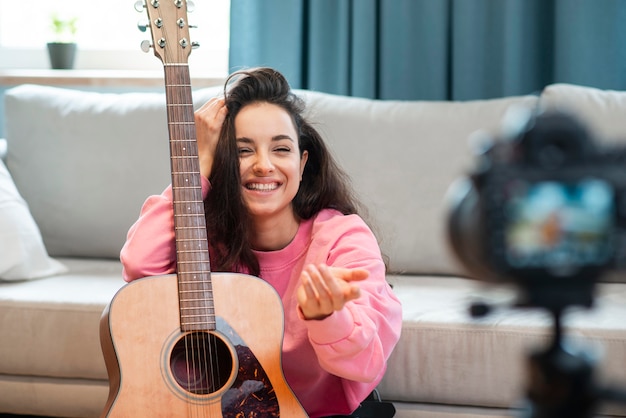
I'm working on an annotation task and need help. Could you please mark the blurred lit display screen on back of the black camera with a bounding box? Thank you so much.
[503,179,615,274]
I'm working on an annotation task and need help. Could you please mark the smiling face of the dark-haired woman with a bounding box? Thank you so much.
[235,102,308,222]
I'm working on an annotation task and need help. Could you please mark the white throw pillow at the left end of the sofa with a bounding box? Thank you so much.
[0,160,67,280]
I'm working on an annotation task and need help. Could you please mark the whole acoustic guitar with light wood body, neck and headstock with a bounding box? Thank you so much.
[100,0,307,418]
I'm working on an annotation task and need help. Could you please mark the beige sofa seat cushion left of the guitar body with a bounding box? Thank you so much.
[0,259,124,380]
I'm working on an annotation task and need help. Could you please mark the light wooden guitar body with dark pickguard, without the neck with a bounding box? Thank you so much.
[100,273,307,418]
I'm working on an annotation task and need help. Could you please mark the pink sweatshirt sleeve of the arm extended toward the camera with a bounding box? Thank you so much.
[303,215,402,386]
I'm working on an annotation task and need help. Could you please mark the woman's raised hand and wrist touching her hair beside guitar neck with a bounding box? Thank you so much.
[194,97,228,178]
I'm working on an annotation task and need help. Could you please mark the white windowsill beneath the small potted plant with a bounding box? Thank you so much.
[0,69,225,88]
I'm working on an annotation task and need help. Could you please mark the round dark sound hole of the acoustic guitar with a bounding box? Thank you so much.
[170,332,233,395]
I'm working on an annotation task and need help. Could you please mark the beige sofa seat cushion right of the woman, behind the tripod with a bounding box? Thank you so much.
[379,276,626,416]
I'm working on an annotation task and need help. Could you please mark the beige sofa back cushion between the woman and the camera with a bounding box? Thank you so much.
[303,92,537,274]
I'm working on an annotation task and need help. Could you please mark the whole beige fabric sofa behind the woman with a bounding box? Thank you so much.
[0,85,626,418]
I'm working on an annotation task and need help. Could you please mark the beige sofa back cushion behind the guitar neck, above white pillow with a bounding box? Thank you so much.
[5,85,221,258]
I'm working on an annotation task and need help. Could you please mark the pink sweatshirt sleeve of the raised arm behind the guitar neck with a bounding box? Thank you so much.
[120,177,210,282]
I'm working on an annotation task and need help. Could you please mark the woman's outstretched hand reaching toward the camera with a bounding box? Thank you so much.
[297,264,369,319]
